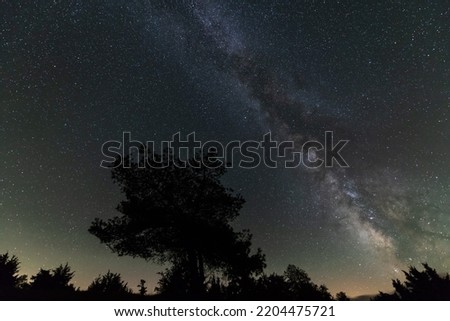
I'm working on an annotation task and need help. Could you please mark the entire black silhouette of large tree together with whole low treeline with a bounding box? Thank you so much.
[0,150,450,301]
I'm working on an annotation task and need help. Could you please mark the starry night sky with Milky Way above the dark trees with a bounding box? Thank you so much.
[0,0,450,296]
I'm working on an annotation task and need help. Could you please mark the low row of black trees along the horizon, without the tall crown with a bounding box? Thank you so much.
[0,253,450,301]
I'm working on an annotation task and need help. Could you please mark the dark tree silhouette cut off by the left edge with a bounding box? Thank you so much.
[0,253,27,297]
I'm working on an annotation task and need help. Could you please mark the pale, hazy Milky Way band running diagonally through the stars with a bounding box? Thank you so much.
[175,1,449,292]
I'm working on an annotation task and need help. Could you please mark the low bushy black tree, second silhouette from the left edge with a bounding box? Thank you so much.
[30,263,75,298]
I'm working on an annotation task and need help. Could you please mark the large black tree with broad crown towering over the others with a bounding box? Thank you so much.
[89,150,264,295]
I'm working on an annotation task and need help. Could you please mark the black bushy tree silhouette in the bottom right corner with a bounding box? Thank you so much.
[375,263,450,301]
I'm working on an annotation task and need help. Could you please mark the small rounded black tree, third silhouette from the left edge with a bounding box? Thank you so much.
[87,271,131,298]
